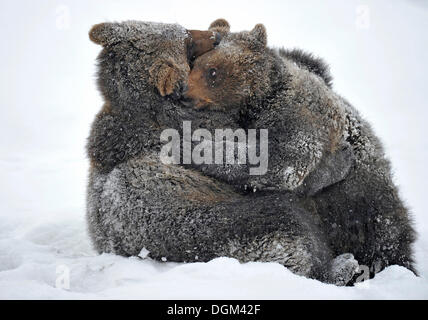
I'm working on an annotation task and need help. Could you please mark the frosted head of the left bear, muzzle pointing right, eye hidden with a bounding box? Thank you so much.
[89,21,220,102]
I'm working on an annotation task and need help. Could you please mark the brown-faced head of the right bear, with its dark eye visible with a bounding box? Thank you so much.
[184,19,271,110]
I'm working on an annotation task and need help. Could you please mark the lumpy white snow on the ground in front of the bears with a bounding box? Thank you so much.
[0,218,428,299]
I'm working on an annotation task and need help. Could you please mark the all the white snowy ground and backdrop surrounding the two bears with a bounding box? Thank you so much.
[0,0,428,299]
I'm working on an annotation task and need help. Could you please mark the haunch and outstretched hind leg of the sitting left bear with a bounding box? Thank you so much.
[88,154,342,283]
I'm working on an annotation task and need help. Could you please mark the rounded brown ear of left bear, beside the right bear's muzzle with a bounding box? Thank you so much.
[149,60,189,99]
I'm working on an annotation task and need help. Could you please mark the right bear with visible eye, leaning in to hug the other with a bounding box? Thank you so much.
[185,20,415,273]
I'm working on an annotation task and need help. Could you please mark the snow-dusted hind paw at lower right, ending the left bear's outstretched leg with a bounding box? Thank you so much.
[329,253,358,286]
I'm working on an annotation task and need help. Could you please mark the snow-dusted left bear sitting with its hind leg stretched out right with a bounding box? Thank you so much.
[87,21,353,284]
